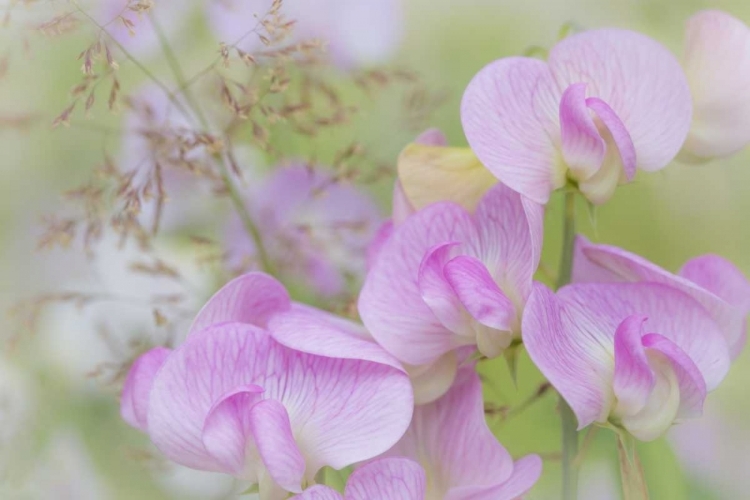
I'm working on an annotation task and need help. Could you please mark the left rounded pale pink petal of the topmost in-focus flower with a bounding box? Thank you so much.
[461,57,560,203]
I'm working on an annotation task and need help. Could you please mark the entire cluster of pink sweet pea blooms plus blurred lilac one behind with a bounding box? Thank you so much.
[114,6,750,500]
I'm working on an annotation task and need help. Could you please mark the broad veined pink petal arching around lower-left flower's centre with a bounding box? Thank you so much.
[148,323,413,477]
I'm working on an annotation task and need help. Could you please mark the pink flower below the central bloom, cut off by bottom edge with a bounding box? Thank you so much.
[386,366,542,500]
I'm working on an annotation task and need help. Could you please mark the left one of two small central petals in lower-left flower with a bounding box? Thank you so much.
[202,385,263,480]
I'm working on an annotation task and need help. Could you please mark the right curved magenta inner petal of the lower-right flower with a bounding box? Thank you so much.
[643,333,706,418]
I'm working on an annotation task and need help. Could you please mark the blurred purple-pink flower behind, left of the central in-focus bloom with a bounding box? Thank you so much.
[226,165,382,297]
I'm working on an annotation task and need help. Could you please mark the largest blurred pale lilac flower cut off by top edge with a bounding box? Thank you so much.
[208,0,403,68]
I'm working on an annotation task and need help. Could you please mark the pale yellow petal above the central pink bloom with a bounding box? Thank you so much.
[398,143,497,210]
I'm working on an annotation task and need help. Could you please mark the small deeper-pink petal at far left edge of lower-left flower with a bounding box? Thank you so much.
[120,347,172,432]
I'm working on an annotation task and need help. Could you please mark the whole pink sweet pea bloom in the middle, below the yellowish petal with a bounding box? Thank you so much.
[359,185,543,402]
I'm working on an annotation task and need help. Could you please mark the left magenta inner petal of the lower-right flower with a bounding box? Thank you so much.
[613,315,654,414]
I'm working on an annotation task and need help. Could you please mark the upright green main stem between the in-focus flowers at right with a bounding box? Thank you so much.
[557,190,578,500]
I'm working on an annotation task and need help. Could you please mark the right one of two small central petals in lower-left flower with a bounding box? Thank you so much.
[248,399,305,493]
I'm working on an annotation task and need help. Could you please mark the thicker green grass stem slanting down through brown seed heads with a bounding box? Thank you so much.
[150,11,274,274]
